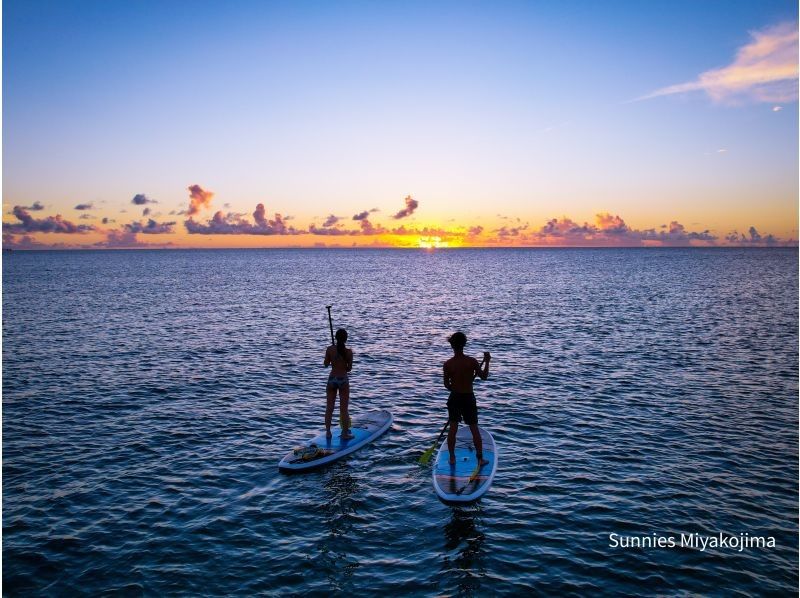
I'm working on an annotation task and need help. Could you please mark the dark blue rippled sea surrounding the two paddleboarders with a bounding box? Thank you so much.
[3,249,798,595]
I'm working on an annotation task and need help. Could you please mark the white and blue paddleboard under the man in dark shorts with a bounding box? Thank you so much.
[433,425,497,503]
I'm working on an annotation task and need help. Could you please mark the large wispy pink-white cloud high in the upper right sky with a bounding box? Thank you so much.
[635,22,798,103]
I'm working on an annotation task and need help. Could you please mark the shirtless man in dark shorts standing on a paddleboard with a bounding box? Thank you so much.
[444,332,492,465]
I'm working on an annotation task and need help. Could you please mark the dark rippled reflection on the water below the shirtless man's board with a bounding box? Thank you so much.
[441,504,486,595]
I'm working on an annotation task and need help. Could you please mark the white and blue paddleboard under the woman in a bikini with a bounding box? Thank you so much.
[278,410,392,472]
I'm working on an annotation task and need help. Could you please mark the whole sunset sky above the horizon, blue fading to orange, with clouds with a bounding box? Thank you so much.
[2,0,798,249]
